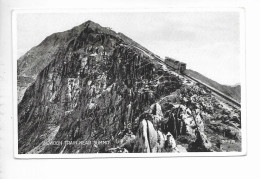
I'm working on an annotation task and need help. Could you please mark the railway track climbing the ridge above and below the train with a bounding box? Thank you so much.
[129,45,241,109]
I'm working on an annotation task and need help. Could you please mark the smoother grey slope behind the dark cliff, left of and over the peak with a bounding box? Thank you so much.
[17,21,152,103]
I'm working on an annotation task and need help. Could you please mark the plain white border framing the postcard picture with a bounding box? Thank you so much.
[12,8,247,159]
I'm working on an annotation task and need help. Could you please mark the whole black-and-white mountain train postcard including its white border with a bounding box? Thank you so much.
[12,8,246,158]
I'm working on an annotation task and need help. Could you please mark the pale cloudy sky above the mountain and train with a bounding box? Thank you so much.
[17,12,240,85]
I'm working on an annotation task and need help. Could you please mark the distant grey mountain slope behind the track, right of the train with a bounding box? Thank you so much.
[186,69,241,102]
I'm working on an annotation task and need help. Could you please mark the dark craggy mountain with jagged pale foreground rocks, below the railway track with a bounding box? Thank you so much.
[18,21,241,153]
